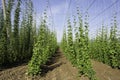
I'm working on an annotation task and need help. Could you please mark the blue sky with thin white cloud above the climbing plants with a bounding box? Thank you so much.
[0,0,120,42]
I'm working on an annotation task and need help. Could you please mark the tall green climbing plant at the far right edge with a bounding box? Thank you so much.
[109,16,120,68]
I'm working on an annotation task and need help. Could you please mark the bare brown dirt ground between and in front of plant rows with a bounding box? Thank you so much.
[0,50,120,80]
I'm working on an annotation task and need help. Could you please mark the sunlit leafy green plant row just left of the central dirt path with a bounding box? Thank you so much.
[28,15,57,75]
